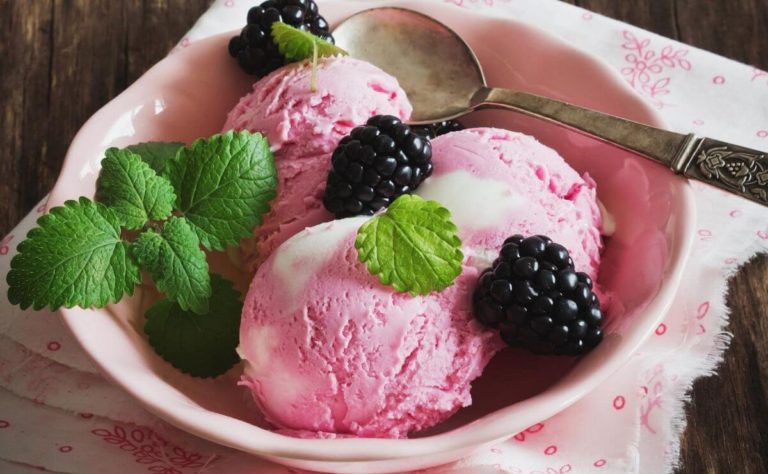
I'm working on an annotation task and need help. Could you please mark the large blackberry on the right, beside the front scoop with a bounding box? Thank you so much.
[473,235,603,355]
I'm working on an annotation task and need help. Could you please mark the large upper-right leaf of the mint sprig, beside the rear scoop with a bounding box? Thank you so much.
[167,132,277,250]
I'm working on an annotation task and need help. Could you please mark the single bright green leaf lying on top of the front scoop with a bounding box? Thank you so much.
[355,195,464,295]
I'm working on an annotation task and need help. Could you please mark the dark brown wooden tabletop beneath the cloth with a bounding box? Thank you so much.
[0,0,768,474]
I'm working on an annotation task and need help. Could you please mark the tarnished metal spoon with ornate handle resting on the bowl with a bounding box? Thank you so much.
[333,7,768,206]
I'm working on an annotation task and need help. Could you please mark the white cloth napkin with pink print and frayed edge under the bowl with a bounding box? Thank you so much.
[0,0,768,474]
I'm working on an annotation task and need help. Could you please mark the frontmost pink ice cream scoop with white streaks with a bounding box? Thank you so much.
[238,218,502,437]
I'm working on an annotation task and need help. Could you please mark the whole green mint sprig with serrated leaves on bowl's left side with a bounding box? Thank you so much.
[7,132,277,377]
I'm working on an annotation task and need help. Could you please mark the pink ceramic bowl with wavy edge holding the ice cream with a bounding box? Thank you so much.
[51,1,694,472]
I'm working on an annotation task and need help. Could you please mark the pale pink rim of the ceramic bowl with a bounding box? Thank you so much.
[49,0,696,462]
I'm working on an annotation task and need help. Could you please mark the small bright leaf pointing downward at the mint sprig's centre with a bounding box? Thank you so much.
[131,217,211,314]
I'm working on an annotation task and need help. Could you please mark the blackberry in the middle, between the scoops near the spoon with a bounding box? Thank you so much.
[323,115,432,218]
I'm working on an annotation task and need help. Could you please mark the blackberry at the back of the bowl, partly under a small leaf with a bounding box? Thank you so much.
[229,0,334,77]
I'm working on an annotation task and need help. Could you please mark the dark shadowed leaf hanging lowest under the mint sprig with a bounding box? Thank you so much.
[144,274,243,377]
